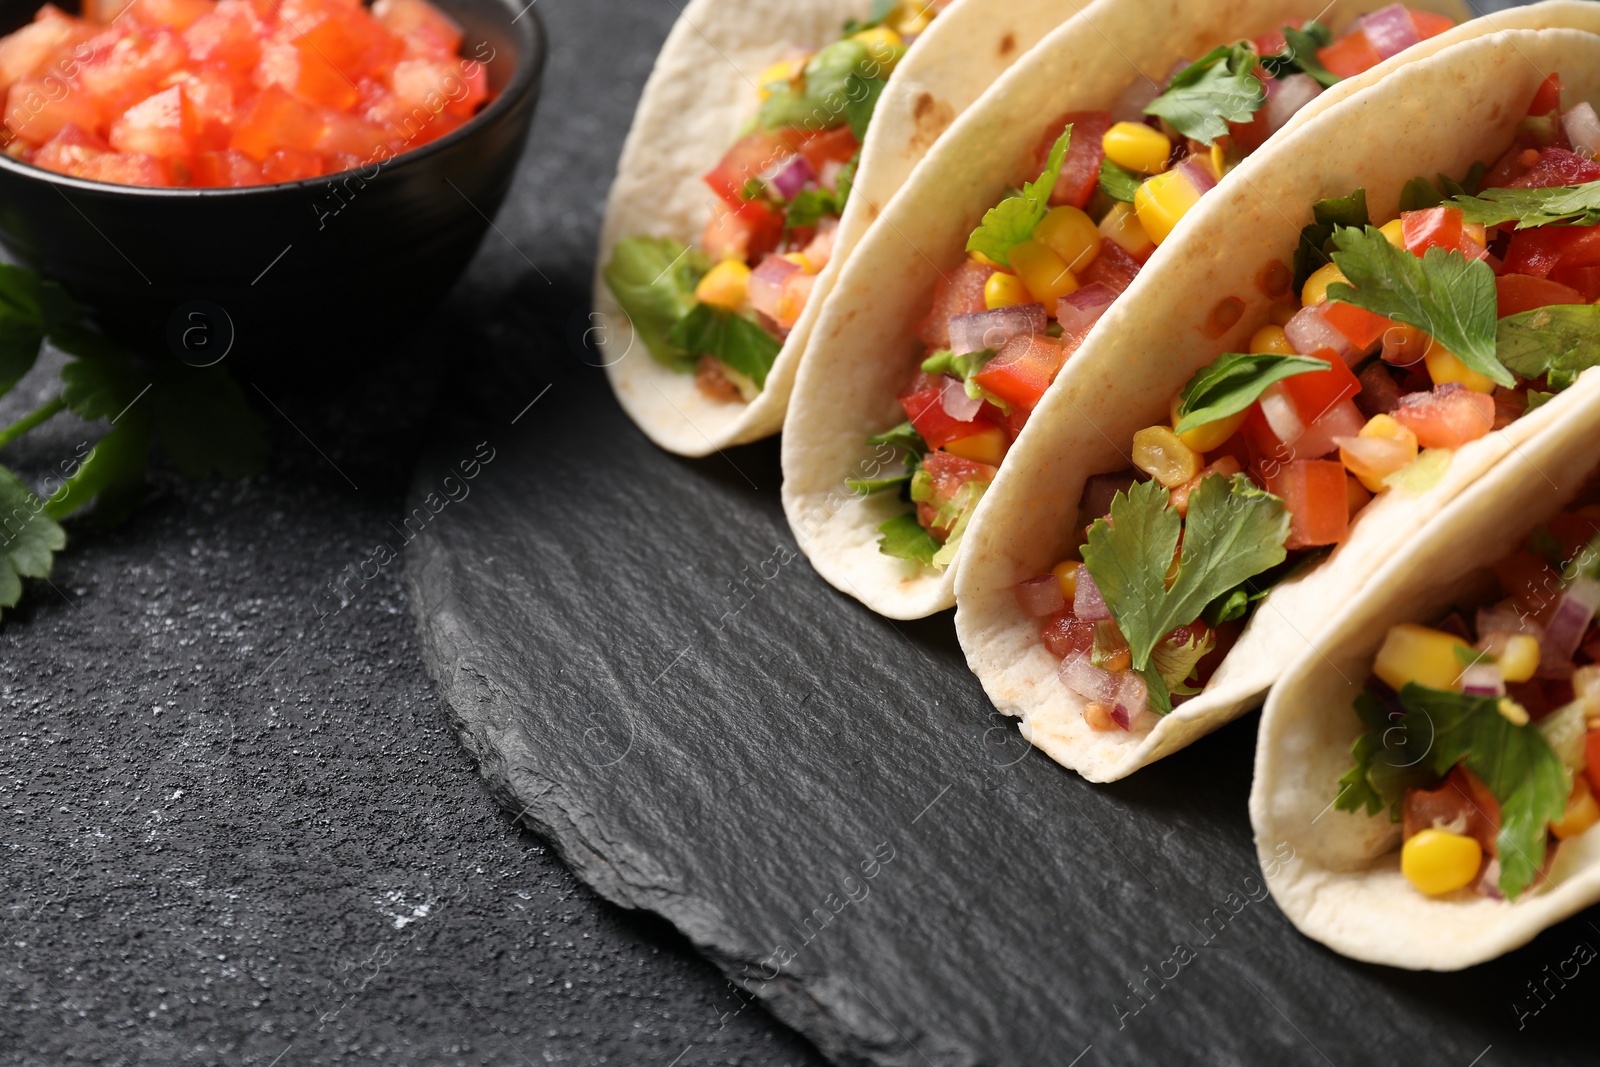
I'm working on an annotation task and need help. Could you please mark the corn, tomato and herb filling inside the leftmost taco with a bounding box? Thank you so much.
[603,0,950,402]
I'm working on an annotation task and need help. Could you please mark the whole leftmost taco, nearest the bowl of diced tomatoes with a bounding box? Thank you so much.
[589,0,1078,456]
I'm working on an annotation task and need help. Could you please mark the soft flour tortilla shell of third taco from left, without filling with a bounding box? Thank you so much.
[955,20,1600,781]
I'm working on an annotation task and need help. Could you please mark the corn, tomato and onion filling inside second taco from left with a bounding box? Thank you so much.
[850,5,1454,568]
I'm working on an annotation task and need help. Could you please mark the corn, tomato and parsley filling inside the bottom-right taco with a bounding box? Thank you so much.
[1334,504,1600,901]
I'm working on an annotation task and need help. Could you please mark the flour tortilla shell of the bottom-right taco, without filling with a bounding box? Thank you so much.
[1250,377,1600,971]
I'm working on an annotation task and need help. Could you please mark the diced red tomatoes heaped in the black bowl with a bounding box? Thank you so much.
[0,0,491,186]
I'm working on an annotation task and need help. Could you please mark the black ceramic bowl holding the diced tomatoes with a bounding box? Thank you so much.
[0,0,544,363]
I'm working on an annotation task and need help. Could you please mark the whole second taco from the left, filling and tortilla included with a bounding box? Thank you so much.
[784,0,1461,617]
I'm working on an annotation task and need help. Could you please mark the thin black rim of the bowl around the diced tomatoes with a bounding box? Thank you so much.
[0,0,549,200]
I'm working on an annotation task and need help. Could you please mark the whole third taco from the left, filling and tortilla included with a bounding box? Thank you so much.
[957,14,1600,781]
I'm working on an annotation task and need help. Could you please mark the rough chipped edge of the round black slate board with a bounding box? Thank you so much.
[405,556,921,1067]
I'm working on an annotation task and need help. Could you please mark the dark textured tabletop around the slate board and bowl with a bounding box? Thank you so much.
[0,0,821,1067]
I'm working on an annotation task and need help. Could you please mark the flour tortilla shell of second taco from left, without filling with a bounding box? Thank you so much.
[784,0,1472,619]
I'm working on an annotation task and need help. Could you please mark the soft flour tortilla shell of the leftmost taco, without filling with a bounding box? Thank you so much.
[592,0,1082,456]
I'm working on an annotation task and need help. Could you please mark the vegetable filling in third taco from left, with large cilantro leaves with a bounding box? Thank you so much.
[1016,75,1600,733]
